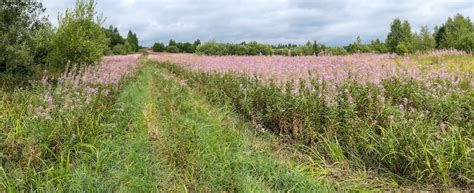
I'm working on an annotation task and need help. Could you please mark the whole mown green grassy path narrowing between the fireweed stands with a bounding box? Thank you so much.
[36,60,331,192]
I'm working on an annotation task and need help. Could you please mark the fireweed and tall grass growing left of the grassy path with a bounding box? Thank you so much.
[0,55,140,189]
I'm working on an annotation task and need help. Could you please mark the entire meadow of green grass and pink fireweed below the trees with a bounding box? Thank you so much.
[0,51,474,192]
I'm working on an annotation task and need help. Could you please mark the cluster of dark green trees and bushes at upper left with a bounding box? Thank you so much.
[0,0,140,74]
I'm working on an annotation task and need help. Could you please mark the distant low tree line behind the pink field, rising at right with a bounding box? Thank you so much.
[153,14,474,56]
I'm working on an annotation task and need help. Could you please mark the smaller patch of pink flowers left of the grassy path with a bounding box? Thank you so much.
[29,55,139,120]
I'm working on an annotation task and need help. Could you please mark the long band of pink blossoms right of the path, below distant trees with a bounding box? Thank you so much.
[149,50,473,92]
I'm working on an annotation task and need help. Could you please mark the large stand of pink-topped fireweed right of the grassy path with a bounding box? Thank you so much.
[153,50,474,188]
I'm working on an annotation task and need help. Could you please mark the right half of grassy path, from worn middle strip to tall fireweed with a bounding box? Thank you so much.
[144,61,328,192]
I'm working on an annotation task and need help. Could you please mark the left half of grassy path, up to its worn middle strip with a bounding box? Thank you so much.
[59,61,173,192]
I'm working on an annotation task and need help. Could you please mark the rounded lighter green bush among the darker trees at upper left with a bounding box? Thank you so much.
[47,0,109,69]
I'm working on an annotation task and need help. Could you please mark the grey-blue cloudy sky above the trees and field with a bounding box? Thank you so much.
[42,0,474,46]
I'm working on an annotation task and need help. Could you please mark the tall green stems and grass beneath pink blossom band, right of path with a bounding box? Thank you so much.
[161,53,474,188]
